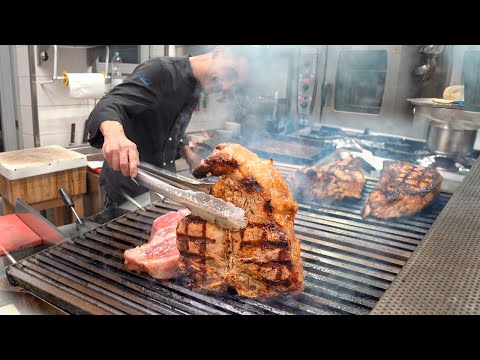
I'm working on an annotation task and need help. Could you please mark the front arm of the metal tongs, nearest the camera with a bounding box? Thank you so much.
[133,168,247,230]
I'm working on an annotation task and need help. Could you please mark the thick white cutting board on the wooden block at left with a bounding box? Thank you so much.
[0,145,87,180]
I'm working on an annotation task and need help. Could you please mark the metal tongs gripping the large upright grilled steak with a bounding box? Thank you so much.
[132,162,247,230]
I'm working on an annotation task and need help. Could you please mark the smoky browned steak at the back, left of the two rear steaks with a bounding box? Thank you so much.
[287,156,365,202]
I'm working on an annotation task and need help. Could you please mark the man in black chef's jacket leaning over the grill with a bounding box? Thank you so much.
[87,46,252,206]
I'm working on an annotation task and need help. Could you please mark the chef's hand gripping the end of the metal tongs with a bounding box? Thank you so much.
[100,120,139,177]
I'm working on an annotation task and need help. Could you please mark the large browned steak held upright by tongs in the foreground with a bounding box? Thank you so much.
[177,143,303,298]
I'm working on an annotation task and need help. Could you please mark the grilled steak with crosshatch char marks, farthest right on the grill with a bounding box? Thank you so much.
[362,161,443,219]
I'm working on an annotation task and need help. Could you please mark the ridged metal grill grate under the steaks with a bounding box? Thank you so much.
[6,164,451,315]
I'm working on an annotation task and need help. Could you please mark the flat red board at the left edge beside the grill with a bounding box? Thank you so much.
[0,214,43,256]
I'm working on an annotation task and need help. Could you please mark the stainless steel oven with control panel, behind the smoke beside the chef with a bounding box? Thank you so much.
[240,45,423,137]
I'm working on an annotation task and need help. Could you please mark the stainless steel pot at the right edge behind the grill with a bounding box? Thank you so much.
[427,121,477,155]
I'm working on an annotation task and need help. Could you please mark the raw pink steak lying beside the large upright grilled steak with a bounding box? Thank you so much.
[123,209,190,279]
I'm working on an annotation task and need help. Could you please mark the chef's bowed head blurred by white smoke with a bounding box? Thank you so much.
[199,45,253,94]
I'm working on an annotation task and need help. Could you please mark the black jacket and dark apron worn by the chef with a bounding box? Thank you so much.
[87,56,201,204]
